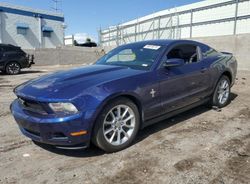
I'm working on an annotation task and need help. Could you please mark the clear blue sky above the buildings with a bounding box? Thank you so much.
[0,0,200,41]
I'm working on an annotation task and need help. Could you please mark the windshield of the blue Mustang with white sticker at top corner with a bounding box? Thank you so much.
[96,44,163,70]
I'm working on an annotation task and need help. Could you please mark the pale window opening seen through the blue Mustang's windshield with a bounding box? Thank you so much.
[107,49,136,63]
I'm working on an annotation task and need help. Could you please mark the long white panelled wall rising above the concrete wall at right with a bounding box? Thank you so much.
[99,0,250,47]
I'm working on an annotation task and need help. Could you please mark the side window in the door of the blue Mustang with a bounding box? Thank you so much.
[167,44,201,64]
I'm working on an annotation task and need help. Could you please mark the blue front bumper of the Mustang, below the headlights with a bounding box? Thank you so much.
[11,100,90,147]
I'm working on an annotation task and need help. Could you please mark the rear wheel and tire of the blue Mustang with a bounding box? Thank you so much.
[211,75,231,108]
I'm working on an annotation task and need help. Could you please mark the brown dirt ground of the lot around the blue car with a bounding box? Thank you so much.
[0,67,250,184]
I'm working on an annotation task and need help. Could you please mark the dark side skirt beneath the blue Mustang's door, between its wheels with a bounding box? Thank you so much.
[141,98,209,129]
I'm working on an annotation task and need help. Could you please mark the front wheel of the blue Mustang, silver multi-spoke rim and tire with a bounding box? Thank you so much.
[92,98,140,153]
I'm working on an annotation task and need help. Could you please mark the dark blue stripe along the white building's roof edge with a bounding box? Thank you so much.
[0,6,64,22]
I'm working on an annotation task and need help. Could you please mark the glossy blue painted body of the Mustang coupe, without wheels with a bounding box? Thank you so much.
[11,40,237,149]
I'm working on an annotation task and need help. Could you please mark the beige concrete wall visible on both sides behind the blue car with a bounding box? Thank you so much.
[26,34,250,70]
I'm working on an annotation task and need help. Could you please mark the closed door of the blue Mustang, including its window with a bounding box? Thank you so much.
[158,43,209,113]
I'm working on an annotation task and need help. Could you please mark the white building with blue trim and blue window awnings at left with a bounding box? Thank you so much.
[0,3,64,49]
